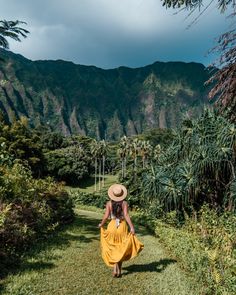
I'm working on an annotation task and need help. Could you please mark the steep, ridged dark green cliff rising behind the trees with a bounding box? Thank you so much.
[0,50,209,139]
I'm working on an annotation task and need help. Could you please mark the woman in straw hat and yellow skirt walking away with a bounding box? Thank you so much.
[98,184,144,277]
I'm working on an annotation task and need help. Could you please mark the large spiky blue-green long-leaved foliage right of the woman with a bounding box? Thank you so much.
[143,109,236,211]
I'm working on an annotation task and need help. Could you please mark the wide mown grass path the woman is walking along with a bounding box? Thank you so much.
[0,210,198,295]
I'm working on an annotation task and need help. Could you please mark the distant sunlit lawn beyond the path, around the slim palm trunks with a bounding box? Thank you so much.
[66,175,118,193]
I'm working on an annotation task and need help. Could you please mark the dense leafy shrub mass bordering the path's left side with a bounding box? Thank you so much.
[0,163,74,271]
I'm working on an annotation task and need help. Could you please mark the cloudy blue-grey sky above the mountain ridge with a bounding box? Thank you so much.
[0,0,232,68]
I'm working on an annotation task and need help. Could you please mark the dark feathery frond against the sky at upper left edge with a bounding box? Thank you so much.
[0,20,29,49]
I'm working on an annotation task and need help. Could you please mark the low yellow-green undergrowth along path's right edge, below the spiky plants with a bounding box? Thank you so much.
[132,206,236,295]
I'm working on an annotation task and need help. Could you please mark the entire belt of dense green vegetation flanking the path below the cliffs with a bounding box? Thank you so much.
[0,109,236,294]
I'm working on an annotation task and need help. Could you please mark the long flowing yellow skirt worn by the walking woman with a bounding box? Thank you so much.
[101,219,144,267]
